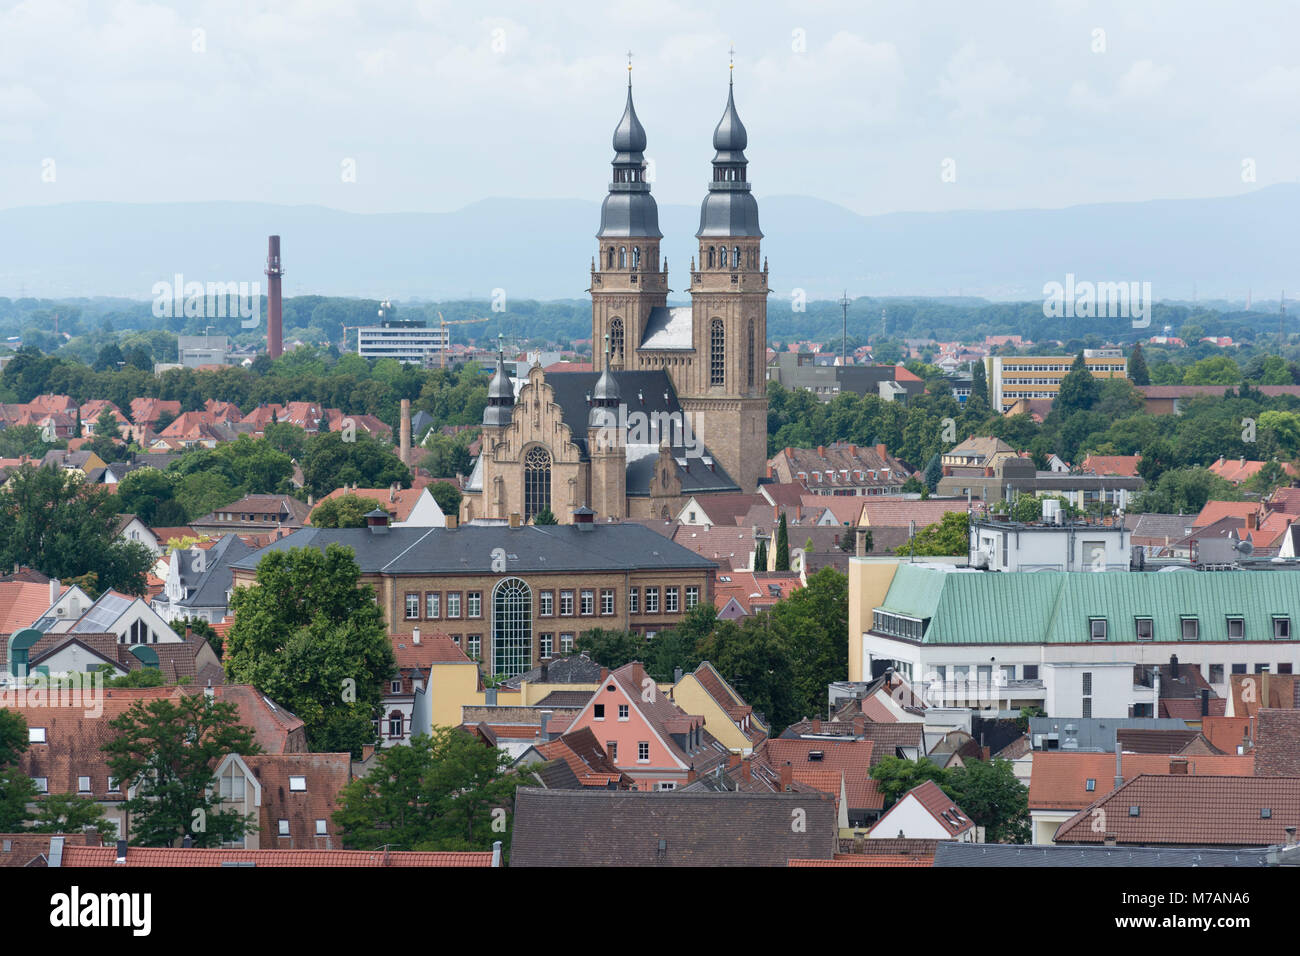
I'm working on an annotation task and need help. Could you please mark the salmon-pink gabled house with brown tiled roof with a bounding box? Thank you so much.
[568,661,728,791]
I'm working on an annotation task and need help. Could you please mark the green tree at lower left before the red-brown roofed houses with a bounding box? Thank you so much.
[103,693,261,847]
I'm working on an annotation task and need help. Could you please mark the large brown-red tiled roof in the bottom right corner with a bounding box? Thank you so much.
[1056,774,1300,847]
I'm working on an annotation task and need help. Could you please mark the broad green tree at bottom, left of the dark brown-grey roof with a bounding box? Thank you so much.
[334,727,529,851]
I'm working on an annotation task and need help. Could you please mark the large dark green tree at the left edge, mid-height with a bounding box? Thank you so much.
[0,464,153,594]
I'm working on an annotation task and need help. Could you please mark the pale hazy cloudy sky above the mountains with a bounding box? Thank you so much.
[0,0,1300,213]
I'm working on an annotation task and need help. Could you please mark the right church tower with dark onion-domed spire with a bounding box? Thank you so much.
[679,71,768,492]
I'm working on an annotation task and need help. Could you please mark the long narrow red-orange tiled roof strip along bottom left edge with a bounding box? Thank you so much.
[64,847,491,866]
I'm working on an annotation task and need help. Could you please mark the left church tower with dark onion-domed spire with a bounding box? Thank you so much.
[590,65,668,372]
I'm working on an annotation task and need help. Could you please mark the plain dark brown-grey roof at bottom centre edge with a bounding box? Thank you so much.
[510,787,837,866]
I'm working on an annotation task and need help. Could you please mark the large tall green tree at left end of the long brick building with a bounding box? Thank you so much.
[225,544,395,754]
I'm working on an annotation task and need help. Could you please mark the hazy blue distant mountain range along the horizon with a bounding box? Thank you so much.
[0,183,1300,302]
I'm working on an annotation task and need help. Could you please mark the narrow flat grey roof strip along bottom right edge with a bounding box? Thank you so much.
[935,843,1269,868]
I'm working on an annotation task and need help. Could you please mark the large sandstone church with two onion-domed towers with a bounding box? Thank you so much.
[460,68,768,523]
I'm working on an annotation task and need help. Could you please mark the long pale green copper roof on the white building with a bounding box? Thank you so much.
[881,564,1300,644]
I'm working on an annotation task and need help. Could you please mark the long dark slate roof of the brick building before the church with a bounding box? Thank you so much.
[231,524,716,574]
